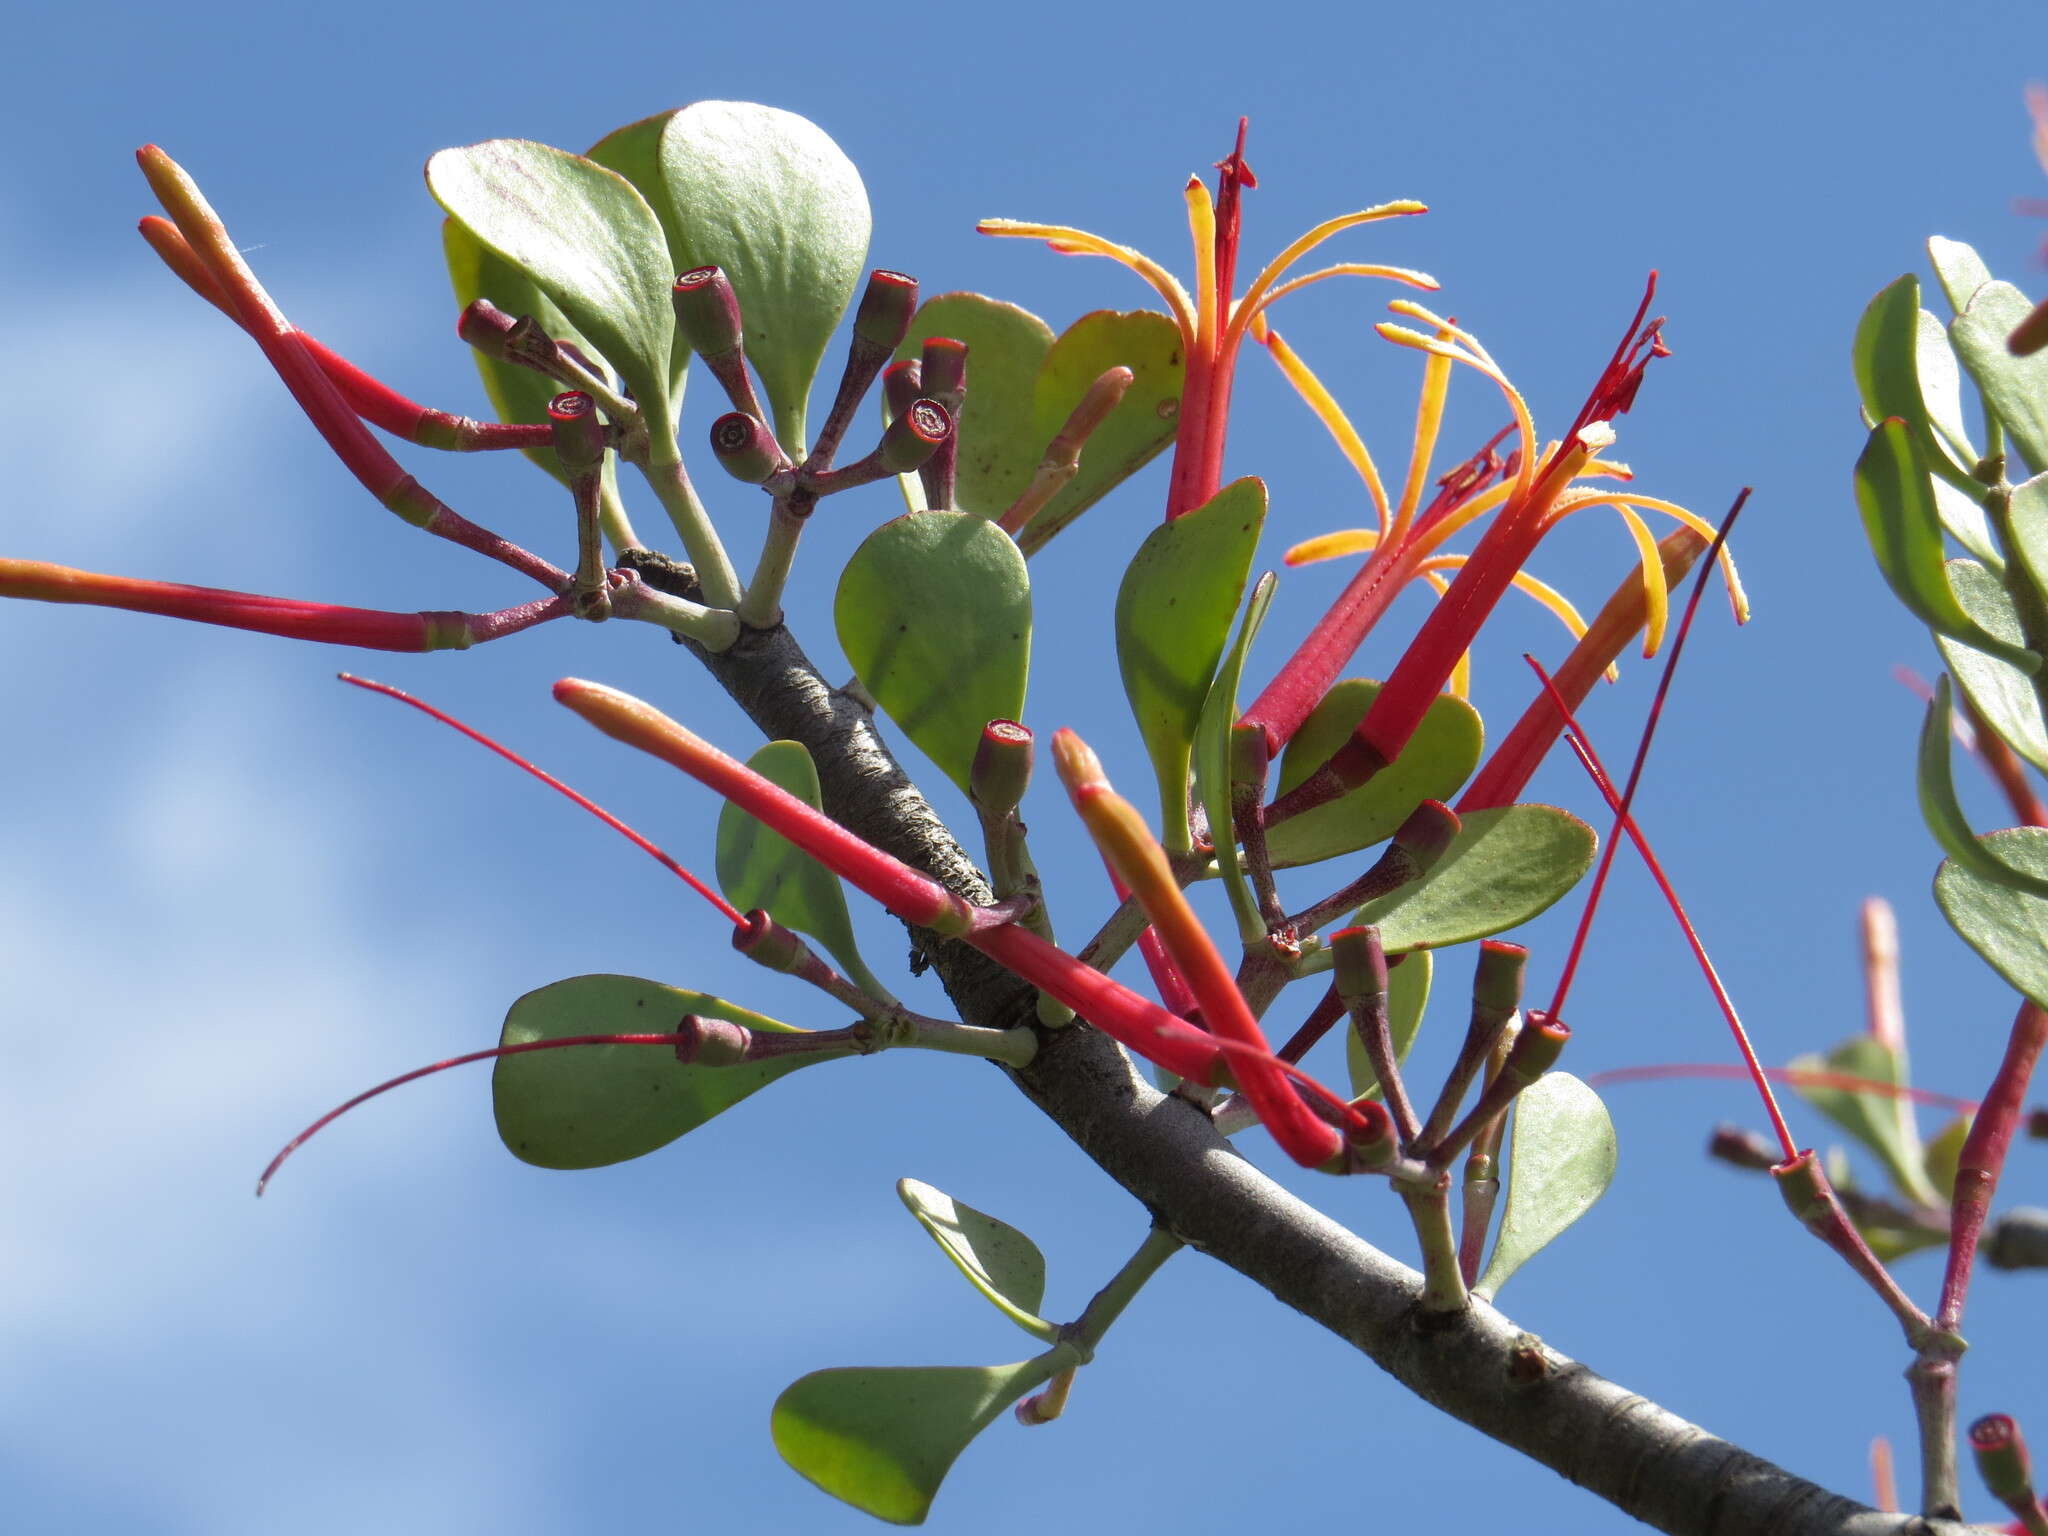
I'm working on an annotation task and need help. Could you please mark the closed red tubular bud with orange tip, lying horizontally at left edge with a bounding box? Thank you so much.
[0,559,567,651]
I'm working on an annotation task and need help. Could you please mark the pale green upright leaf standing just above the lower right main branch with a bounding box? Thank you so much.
[1473,1071,1614,1298]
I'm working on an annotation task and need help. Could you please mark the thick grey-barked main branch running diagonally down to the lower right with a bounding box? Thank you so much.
[643,567,1968,1536]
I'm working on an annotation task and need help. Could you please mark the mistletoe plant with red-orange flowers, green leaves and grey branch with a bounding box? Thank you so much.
[0,102,2048,1532]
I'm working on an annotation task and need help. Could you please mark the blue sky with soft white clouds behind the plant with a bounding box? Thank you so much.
[0,0,2048,1536]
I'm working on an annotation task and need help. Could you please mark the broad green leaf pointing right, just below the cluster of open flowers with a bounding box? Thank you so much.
[1352,805,1599,954]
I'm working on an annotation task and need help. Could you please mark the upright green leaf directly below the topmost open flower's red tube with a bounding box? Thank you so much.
[1116,475,1266,854]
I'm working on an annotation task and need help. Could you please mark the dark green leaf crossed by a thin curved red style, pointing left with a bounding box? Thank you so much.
[492,977,846,1167]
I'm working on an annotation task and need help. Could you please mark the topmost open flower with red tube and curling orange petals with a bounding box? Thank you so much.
[975,119,1436,522]
